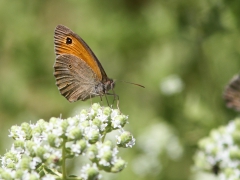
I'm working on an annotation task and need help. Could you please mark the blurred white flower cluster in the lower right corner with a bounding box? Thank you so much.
[194,118,240,180]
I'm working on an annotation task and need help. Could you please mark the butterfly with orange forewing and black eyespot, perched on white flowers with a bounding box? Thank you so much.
[54,25,115,102]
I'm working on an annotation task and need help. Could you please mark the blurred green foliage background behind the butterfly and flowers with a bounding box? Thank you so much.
[0,0,240,180]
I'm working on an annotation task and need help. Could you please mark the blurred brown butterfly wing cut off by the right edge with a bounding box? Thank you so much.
[223,75,240,111]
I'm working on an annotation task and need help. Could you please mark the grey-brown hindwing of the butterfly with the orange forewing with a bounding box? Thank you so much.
[54,54,100,102]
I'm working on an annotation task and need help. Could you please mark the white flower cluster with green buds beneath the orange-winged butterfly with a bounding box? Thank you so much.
[0,104,135,180]
